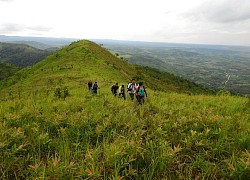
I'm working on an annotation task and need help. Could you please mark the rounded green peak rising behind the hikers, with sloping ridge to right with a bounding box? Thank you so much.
[2,40,213,94]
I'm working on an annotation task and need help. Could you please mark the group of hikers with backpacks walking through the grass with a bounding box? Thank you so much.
[88,79,147,105]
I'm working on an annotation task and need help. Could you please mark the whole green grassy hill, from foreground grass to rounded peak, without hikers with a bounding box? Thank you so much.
[0,41,250,179]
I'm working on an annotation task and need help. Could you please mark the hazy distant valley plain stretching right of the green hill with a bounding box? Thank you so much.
[94,40,250,95]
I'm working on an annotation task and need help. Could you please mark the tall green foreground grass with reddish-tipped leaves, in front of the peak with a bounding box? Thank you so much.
[0,84,250,179]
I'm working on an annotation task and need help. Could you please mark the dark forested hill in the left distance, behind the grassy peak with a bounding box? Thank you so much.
[0,42,52,67]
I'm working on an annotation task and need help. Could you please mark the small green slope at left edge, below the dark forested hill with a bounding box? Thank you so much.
[0,62,21,81]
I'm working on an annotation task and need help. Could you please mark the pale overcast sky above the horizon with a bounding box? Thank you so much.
[0,0,250,45]
